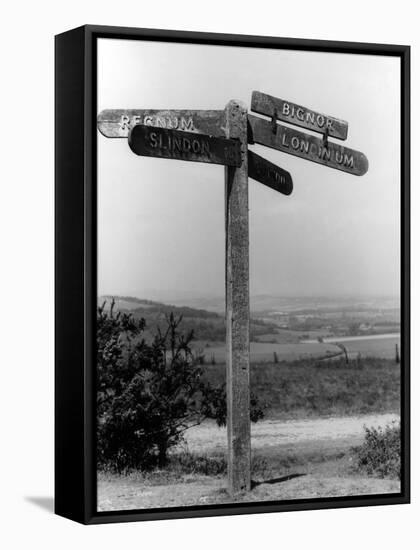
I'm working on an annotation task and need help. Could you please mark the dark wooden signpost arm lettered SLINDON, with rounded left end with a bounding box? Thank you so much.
[128,124,241,166]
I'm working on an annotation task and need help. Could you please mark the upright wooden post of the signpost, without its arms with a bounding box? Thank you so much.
[225,101,251,494]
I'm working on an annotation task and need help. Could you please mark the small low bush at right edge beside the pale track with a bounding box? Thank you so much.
[355,422,401,479]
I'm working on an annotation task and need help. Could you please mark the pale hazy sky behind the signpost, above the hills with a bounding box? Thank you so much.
[98,39,400,300]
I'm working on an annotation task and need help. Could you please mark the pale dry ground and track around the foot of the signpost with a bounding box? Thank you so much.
[98,414,400,511]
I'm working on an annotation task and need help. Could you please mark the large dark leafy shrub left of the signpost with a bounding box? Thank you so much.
[97,302,264,472]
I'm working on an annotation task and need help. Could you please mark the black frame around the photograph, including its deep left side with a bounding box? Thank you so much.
[55,25,410,524]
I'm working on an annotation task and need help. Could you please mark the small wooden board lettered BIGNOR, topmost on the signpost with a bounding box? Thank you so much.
[251,92,349,139]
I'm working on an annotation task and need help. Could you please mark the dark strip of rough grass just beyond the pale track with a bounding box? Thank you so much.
[204,358,400,419]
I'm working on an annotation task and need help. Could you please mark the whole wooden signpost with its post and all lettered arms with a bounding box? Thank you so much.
[98,92,368,495]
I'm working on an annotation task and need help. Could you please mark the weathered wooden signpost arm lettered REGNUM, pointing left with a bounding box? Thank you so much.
[97,109,225,138]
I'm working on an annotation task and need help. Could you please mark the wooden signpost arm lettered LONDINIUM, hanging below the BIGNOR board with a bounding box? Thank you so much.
[248,115,369,176]
